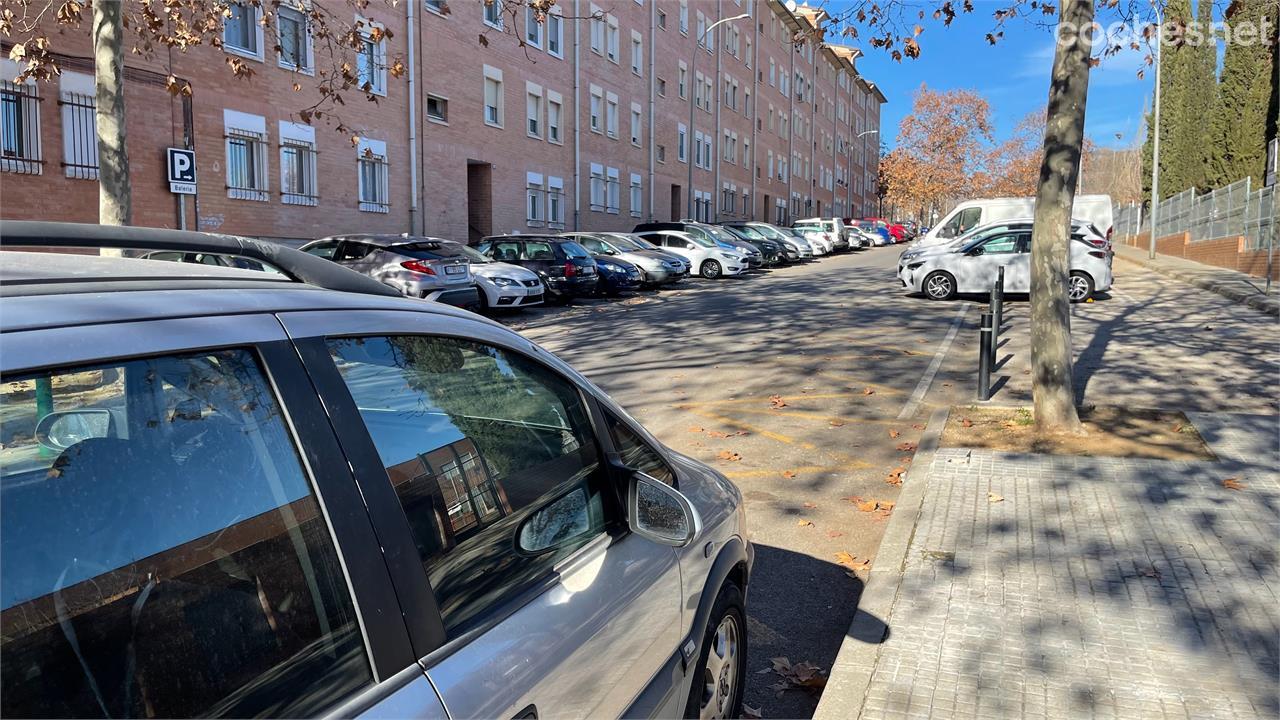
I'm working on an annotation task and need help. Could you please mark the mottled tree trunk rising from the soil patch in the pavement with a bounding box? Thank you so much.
[1030,0,1093,432]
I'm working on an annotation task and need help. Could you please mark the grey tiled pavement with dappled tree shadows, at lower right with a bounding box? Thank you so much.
[861,414,1280,719]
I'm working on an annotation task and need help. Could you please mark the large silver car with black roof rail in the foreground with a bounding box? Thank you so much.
[0,220,754,719]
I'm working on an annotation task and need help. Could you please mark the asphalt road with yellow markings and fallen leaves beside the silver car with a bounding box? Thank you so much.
[502,247,975,717]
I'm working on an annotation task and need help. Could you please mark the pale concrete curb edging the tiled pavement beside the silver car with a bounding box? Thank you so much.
[813,407,950,720]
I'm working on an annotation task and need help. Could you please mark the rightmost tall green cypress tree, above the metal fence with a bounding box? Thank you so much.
[1211,0,1280,187]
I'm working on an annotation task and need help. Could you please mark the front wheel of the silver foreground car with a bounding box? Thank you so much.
[685,582,746,720]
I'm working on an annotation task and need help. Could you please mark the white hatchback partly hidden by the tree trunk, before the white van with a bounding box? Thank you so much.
[897,227,1111,302]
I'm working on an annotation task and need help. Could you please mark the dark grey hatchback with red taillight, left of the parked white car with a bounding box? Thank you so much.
[301,234,480,307]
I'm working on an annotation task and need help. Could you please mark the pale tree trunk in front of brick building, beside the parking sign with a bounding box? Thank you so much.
[93,0,133,225]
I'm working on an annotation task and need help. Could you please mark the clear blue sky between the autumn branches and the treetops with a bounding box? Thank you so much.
[827,0,1152,147]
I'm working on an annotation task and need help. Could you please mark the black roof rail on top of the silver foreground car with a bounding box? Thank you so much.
[0,220,401,297]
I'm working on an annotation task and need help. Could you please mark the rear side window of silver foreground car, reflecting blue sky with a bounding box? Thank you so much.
[0,350,372,717]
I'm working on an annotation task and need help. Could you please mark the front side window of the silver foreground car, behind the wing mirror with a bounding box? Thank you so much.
[329,336,621,637]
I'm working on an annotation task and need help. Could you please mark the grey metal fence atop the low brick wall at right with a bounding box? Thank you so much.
[1115,178,1280,250]
